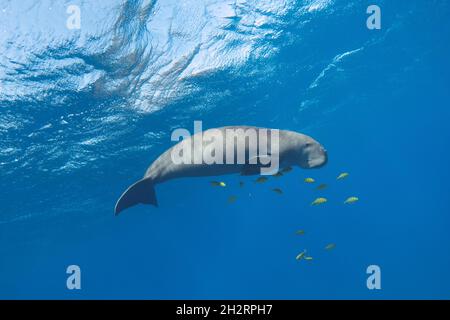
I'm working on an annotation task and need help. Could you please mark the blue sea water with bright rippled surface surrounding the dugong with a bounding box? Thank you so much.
[0,0,450,299]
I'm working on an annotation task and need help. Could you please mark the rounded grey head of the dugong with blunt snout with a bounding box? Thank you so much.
[296,134,328,169]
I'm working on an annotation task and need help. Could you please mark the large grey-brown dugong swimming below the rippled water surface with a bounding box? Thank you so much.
[114,126,328,215]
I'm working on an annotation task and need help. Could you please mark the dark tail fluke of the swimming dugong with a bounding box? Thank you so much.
[114,178,158,215]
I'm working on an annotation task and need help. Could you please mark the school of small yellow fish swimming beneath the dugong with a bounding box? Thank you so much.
[211,167,359,261]
